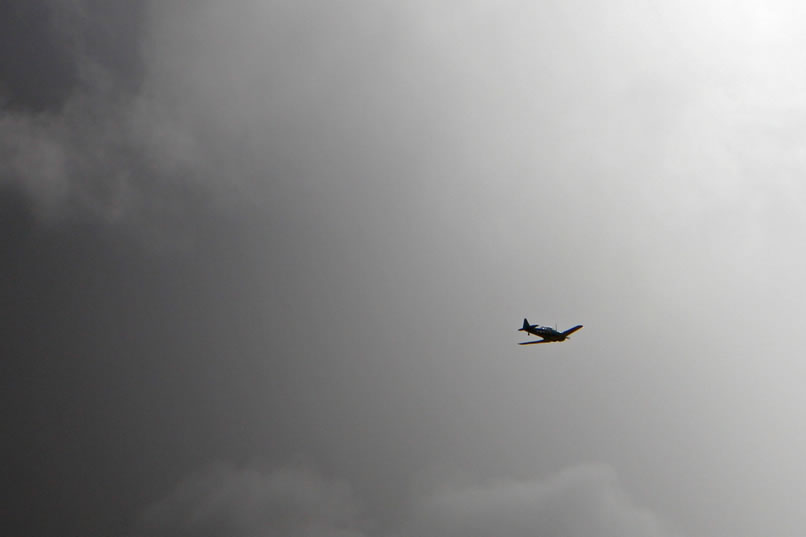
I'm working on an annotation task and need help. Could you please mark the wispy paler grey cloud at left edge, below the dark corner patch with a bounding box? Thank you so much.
[0,77,203,231]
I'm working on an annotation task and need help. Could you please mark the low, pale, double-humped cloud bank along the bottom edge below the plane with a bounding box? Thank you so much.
[137,465,674,537]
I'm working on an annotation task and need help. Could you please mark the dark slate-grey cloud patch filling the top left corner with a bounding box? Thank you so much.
[0,0,145,111]
